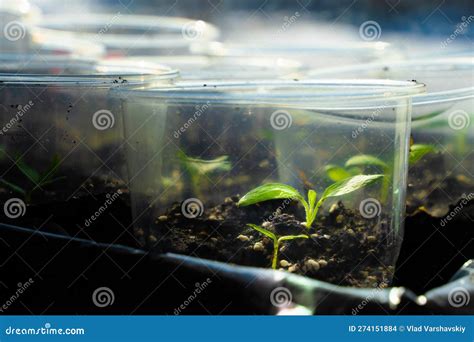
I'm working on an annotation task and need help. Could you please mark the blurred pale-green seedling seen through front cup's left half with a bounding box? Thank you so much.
[178,151,232,194]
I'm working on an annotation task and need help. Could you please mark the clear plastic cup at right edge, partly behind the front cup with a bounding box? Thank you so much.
[310,57,474,217]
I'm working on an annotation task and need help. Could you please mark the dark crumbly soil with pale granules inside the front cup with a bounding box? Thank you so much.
[144,196,393,287]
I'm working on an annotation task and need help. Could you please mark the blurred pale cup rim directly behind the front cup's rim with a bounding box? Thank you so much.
[117,55,308,81]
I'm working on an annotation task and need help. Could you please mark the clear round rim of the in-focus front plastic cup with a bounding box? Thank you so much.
[115,79,425,109]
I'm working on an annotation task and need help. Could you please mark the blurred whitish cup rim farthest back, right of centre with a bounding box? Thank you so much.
[191,41,401,69]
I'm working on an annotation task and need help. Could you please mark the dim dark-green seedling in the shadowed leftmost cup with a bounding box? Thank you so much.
[0,155,66,203]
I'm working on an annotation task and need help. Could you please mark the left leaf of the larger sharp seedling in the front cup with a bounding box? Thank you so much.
[238,183,306,206]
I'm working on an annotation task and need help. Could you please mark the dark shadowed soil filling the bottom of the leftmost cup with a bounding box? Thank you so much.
[0,177,139,247]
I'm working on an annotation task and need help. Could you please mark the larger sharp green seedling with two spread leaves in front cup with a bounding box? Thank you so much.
[238,175,383,229]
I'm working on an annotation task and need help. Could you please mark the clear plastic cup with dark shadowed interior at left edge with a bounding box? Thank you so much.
[0,56,178,211]
